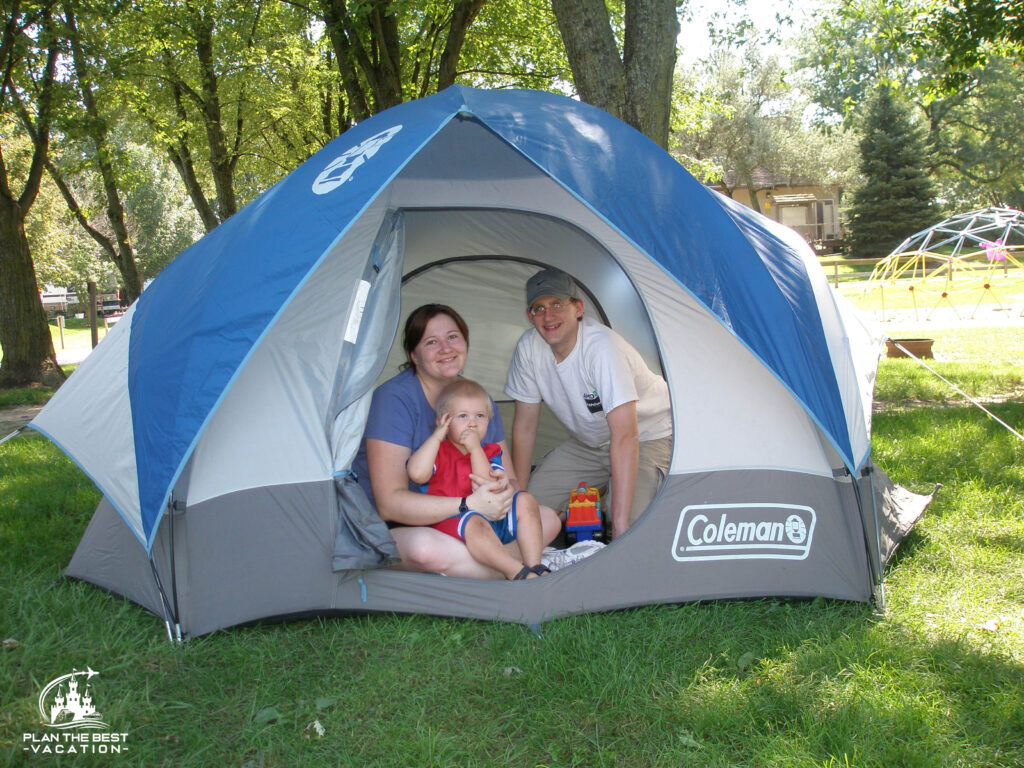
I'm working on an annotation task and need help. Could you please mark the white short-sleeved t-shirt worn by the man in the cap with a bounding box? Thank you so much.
[505,316,672,447]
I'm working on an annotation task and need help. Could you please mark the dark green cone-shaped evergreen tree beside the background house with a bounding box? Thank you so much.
[846,86,939,258]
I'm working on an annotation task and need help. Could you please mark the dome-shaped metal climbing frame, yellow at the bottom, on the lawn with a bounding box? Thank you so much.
[864,208,1024,319]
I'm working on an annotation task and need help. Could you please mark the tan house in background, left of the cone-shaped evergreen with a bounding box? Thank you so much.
[710,168,843,253]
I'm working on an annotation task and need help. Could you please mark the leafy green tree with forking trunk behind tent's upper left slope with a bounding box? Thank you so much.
[106,0,323,230]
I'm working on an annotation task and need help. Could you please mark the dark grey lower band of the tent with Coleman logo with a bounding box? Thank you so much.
[67,462,932,636]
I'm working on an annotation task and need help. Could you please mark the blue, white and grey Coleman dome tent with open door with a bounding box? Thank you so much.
[31,87,929,637]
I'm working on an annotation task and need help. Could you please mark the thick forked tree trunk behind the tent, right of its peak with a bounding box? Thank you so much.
[551,0,679,148]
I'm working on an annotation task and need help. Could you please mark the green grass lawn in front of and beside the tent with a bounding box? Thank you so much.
[0,332,1024,768]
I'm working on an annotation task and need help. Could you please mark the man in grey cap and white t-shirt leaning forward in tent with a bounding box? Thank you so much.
[505,269,672,538]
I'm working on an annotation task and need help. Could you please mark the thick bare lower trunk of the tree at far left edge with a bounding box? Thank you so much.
[0,196,65,388]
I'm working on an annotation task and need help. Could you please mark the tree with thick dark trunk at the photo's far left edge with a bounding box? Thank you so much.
[0,0,65,387]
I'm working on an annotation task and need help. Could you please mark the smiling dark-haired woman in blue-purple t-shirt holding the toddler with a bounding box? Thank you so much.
[353,304,561,579]
